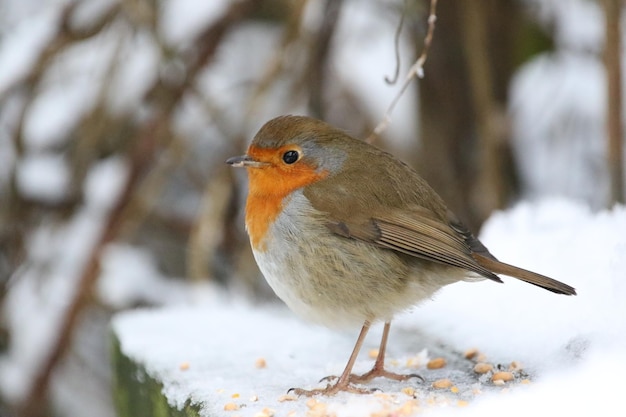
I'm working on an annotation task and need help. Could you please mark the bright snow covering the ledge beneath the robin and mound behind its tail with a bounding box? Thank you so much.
[113,199,626,416]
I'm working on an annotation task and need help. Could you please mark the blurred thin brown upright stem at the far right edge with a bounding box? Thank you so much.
[602,0,624,205]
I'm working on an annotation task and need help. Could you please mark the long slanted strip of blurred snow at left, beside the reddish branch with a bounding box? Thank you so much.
[0,157,126,401]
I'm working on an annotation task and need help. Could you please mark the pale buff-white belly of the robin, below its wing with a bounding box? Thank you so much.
[247,194,462,327]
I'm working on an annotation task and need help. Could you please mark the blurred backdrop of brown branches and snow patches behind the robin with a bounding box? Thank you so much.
[0,0,624,417]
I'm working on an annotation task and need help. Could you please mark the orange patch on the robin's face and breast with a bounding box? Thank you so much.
[246,145,328,251]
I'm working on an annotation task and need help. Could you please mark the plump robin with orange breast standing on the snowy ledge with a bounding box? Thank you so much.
[226,116,576,395]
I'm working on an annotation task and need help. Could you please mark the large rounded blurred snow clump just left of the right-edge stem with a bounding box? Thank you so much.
[509,51,608,207]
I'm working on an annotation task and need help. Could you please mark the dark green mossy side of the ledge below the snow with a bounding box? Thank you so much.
[111,334,201,417]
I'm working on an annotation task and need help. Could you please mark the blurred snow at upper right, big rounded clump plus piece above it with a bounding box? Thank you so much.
[508,0,626,209]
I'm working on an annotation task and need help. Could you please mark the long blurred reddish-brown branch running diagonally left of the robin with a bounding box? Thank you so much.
[19,0,262,417]
